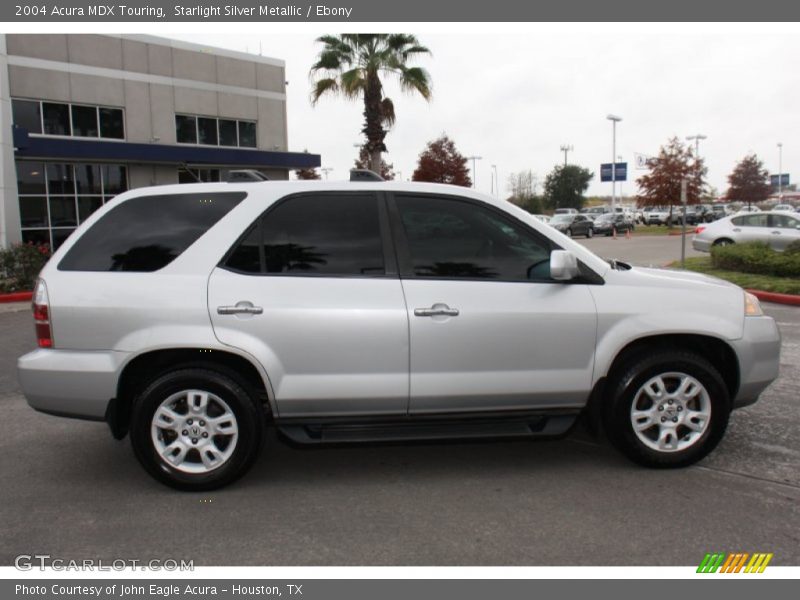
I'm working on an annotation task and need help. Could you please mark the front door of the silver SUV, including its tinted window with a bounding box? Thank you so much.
[391,194,597,414]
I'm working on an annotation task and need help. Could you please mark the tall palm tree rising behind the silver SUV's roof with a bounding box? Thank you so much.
[310,33,431,173]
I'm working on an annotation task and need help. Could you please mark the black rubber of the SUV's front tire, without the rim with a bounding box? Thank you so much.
[603,350,731,468]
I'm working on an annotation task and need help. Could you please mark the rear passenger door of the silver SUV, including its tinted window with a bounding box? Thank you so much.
[208,193,409,417]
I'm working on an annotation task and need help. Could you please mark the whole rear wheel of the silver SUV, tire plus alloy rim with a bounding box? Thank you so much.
[130,368,264,491]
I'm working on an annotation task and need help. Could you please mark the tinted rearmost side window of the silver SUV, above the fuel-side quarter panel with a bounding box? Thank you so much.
[58,192,247,273]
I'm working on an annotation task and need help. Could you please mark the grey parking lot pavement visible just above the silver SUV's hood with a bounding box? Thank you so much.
[575,233,708,267]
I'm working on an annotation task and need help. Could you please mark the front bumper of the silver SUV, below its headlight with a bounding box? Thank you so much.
[730,316,781,408]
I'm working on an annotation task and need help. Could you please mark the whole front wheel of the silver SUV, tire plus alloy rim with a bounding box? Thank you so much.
[603,350,731,468]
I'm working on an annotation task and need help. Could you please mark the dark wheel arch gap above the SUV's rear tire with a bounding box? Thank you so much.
[106,348,275,439]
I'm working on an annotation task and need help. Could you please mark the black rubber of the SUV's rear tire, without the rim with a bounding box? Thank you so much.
[130,368,264,491]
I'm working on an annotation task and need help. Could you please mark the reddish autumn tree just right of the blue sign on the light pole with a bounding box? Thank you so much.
[636,137,707,222]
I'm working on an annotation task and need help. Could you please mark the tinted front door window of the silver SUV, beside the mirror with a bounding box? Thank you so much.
[397,196,551,281]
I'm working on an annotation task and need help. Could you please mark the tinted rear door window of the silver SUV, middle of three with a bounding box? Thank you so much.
[224,194,386,277]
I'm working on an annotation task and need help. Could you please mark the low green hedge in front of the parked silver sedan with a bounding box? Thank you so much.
[711,242,800,277]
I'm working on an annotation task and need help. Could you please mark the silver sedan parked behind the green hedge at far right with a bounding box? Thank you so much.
[692,212,800,252]
